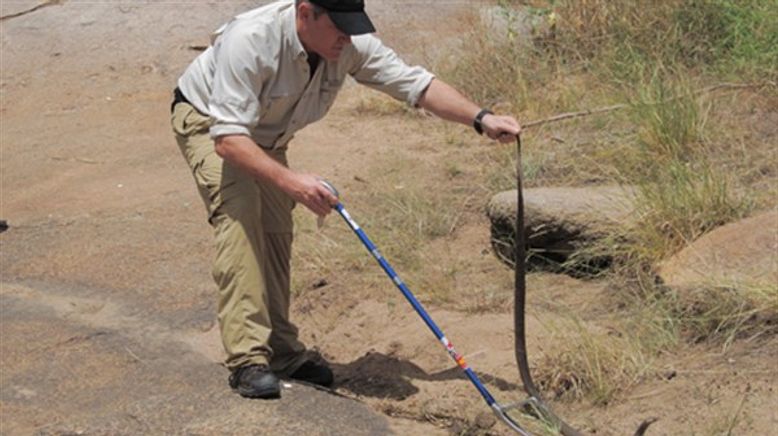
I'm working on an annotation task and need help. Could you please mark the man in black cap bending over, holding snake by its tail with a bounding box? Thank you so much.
[172,0,520,398]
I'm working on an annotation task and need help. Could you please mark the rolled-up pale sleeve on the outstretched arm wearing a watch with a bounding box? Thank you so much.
[349,34,435,106]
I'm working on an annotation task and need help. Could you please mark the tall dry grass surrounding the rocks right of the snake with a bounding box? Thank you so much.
[434,0,778,404]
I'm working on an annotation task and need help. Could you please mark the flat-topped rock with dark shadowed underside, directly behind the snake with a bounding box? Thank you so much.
[487,186,634,269]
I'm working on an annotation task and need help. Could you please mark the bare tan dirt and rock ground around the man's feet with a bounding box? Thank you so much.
[0,0,778,435]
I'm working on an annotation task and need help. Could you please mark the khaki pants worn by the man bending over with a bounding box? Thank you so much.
[171,103,305,374]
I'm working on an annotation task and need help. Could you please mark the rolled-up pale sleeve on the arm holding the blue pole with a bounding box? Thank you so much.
[208,23,269,138]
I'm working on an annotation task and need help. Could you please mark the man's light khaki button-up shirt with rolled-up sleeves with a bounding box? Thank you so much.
[178,0,434,149]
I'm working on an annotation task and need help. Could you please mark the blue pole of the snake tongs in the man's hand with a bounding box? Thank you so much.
[325,203,495,407]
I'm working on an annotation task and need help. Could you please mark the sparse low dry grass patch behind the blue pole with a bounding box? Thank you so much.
[292,150,469,304]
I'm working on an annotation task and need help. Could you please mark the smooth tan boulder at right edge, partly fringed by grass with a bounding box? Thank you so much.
[659,209,778,289]
